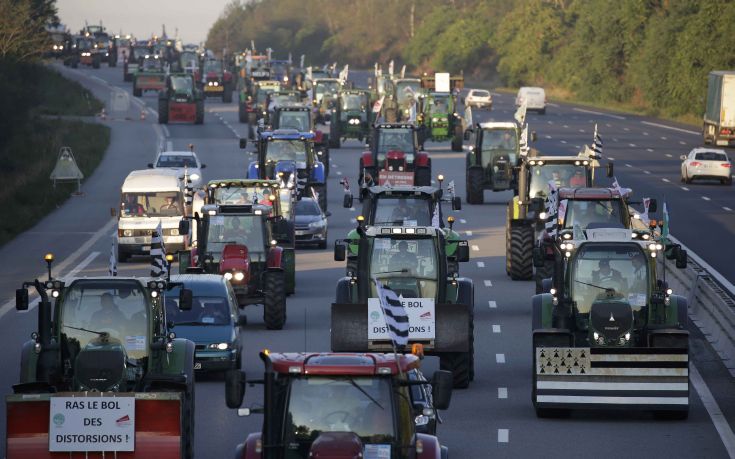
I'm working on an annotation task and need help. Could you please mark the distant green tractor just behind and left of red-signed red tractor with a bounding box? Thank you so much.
[329,89,372,148]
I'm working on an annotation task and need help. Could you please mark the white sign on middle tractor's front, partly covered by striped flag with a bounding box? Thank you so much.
[368,297,436,340]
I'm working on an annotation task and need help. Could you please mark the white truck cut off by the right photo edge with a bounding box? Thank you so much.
[702,70,735,147]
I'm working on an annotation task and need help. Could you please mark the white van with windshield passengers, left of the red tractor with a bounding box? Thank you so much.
[117,169,186,262]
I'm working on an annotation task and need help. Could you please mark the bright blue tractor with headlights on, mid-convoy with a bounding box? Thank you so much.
[246,129,327,211]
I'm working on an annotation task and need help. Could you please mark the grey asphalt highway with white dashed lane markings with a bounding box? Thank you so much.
[0,66,735,458]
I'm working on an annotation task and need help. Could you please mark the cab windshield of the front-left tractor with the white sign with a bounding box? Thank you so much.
[57,280,149,359]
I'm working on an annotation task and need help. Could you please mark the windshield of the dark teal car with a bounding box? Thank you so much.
[165,294,232,326]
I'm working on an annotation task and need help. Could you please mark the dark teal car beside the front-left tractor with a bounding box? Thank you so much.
[166,274,242,371]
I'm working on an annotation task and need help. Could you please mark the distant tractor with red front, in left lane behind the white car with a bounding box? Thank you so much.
[158,73,204,124]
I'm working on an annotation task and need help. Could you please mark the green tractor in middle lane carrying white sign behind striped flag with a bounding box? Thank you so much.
[332,225,474,388]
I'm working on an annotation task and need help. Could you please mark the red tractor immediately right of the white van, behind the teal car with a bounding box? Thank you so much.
[179,204,293,330]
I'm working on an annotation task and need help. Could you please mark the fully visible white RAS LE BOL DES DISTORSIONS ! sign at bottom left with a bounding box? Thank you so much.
[48,397,135,452]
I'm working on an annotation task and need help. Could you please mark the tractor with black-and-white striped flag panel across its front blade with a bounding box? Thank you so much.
[531,227,690,419]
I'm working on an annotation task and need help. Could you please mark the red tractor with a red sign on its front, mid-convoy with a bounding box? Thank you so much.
[358,123,431,199]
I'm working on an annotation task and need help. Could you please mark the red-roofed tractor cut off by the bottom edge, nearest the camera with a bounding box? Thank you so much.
[225,346,452,459]
